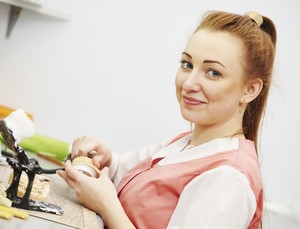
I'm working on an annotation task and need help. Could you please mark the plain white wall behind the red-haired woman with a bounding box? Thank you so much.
[0,0,300,229]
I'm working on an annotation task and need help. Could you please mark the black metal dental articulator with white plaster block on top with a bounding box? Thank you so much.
[0,109,63,214]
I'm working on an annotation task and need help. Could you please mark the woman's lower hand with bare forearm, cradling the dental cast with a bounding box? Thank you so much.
[57,160,135,229]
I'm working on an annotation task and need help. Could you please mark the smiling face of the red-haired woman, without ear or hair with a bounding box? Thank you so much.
[176,29,245,127]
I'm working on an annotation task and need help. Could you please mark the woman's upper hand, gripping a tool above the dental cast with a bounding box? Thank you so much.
[71,135,112,169]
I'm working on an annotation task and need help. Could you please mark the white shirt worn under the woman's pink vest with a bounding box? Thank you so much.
[110,135,256,229]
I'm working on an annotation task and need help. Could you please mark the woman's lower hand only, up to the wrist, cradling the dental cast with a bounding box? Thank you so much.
[57,160,118,215]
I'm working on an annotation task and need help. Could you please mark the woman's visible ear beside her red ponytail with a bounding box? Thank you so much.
[242,78,263,103]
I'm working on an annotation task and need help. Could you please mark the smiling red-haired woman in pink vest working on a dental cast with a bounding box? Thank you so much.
[58,12,276,229]
